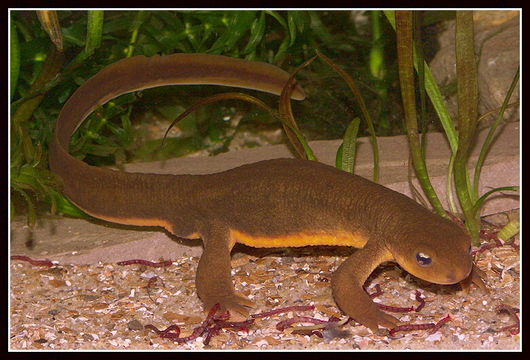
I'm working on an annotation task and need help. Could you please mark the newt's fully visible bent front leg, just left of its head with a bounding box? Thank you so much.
[331,241,400,332]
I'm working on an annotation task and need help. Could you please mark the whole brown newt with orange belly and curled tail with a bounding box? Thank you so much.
[50,54,484,331]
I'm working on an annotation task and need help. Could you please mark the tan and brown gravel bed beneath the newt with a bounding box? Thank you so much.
[10,238,521,350]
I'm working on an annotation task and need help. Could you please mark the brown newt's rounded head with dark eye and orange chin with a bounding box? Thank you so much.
[386,218,473,285]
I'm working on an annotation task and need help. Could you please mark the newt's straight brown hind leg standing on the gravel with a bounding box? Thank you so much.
[195,225,256,321]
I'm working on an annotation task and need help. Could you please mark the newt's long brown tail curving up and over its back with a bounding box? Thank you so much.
[49,54,305,222]
